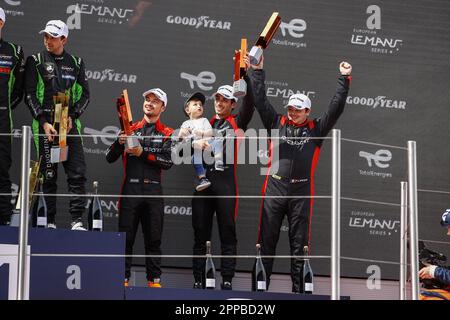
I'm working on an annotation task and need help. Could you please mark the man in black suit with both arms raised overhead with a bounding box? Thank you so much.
[251,54,352,292]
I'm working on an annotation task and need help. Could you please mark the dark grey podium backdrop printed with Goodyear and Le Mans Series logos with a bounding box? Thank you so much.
[4,0,450,279]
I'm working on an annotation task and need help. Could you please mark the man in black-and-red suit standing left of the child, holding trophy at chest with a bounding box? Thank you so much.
[106,88,173,288]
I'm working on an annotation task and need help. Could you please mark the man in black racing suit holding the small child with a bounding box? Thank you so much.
[192,76,254,290]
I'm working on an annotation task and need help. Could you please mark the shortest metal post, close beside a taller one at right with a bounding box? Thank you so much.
[400,181,408,300]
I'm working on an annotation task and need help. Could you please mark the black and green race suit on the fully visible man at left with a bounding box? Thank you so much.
[25,51,89,223]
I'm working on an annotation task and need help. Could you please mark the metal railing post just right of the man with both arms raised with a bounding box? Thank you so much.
[331,129,341,300]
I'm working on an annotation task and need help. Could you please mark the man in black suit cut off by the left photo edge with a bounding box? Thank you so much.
[0,8,25,225]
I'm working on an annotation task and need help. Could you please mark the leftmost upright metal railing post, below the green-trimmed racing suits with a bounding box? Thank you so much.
[17,126,31,300]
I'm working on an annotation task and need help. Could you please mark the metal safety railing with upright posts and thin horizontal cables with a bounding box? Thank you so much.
[1,126,448,300]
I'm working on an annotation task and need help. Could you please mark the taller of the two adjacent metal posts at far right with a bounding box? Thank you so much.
[408,141,419,300]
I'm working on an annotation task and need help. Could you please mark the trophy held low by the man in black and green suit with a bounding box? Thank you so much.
[50,92,69,163]
